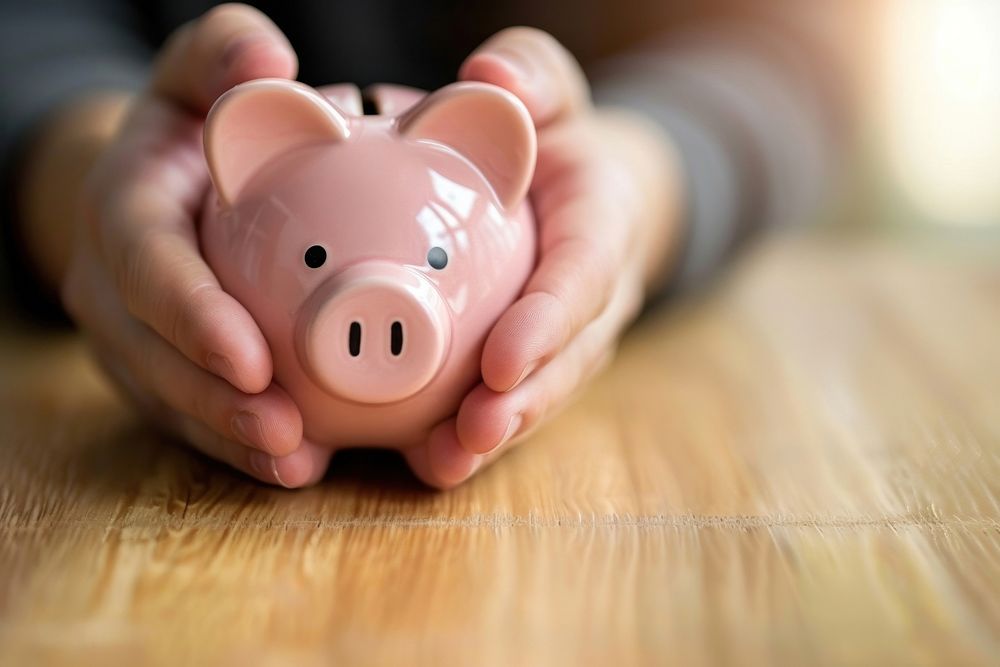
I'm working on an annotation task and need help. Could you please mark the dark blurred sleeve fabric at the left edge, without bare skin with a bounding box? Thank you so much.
[0,0,153,315]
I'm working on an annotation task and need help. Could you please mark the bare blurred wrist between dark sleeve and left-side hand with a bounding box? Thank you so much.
[11,92,131,292]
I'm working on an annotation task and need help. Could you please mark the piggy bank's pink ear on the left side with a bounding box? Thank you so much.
[205,79,349,204]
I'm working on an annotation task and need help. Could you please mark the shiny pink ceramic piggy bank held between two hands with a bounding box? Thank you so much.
[200,79,536,448]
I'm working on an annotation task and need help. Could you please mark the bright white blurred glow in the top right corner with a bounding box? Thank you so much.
[869,0,1000,228]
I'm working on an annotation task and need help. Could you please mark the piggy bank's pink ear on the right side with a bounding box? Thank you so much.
[399,83,537,208]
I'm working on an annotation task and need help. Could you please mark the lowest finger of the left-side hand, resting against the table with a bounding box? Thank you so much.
[176,417,333,489]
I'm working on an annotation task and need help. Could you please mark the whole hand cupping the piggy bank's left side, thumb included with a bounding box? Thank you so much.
[62,5,331,487]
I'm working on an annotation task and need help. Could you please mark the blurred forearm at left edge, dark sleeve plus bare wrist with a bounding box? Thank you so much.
[0,0,152,308]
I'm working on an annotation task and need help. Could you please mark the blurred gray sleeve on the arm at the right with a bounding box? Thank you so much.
[592,7,844,288]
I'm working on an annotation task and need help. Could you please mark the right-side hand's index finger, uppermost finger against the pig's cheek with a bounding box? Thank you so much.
[482,190,630,392]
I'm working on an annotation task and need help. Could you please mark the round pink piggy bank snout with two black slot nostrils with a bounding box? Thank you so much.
[298,262,451,403]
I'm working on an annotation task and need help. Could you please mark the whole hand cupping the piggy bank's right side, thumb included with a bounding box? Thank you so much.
[405,28,681,488]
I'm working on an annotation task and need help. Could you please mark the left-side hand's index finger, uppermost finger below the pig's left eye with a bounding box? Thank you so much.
[101,180,272,393]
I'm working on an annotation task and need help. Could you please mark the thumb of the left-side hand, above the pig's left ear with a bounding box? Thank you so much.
[151,4,298,115]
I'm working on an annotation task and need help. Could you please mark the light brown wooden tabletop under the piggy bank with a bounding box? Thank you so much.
[0,231,1000,665]
